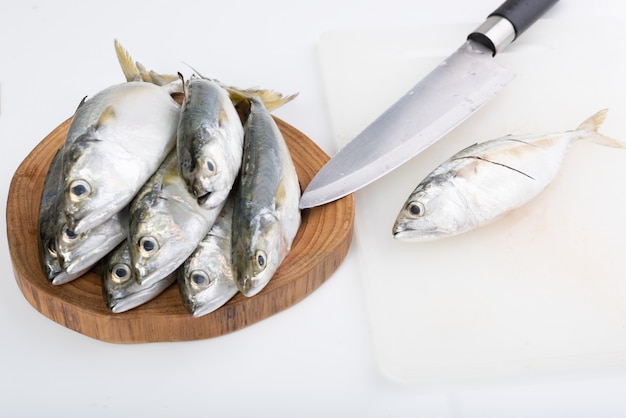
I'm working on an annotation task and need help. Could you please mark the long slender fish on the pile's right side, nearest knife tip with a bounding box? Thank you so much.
[232,97,301,297]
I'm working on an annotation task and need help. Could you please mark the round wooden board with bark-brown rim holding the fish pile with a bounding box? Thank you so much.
[6,118,354,343]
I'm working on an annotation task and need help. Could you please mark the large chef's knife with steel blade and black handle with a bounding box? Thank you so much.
[300,0,558,209]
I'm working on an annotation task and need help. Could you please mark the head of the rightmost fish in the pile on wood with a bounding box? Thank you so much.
[232,211,289,296]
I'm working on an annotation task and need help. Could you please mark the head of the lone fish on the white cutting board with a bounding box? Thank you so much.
[392,174,471,241]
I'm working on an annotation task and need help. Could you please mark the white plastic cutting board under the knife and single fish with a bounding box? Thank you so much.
[319,20,626,382]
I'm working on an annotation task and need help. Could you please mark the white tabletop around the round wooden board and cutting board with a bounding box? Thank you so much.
[0,0,626,417]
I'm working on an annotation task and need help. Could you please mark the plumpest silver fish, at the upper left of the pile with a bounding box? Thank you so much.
[63,82,180,234]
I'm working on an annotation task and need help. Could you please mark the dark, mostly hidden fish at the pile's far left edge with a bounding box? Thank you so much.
[37,150,69,282]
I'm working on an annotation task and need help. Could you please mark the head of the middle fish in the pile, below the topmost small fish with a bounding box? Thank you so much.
[129,192,207,283]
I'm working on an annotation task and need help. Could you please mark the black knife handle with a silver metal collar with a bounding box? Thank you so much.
[467,0,558,55]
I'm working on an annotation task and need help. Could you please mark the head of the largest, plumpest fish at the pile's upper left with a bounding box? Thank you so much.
[63,130,138,234]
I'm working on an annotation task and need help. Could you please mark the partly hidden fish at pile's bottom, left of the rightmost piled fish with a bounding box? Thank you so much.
[178,194,239,317]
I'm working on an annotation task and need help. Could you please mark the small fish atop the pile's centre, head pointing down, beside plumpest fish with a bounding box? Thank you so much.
[176,77,243,208]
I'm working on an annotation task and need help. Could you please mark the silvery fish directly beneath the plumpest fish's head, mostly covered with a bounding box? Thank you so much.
[52,207,128,284]
